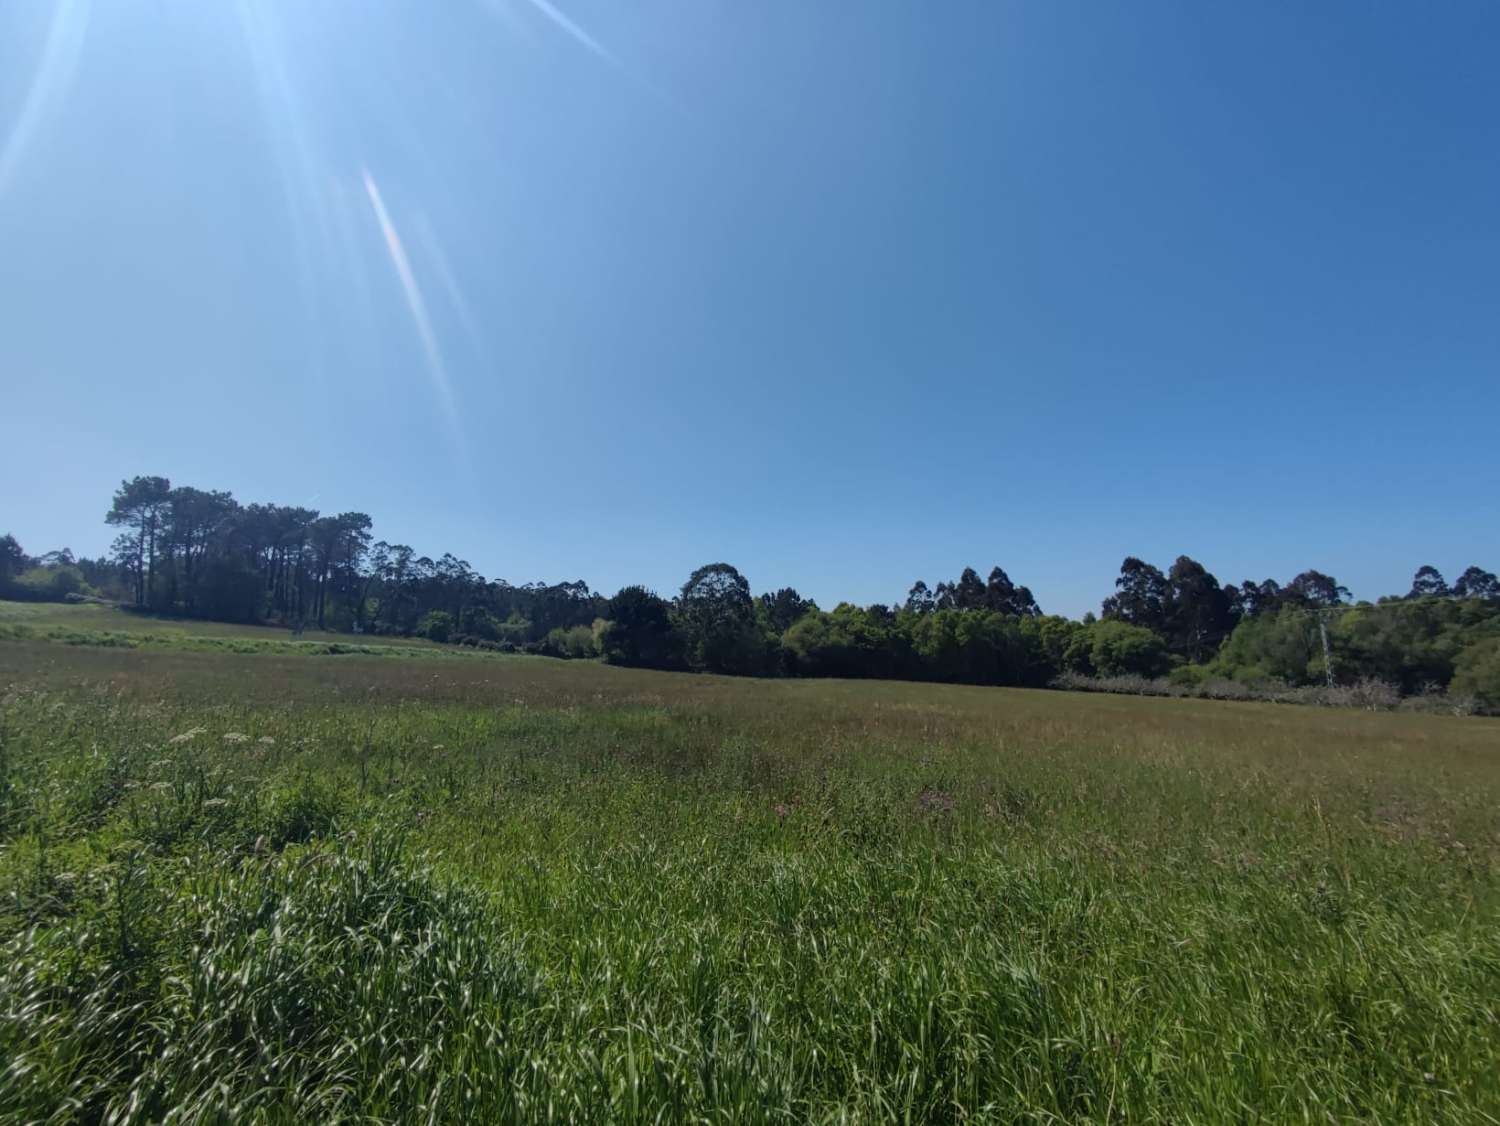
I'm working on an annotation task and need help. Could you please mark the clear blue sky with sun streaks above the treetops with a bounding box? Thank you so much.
[0,0,1500,615]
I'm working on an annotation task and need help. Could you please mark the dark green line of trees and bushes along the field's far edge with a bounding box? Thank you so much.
[0,477,1500,711]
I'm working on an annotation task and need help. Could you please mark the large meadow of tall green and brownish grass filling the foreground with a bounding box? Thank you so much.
[0,640,1500,1123]
